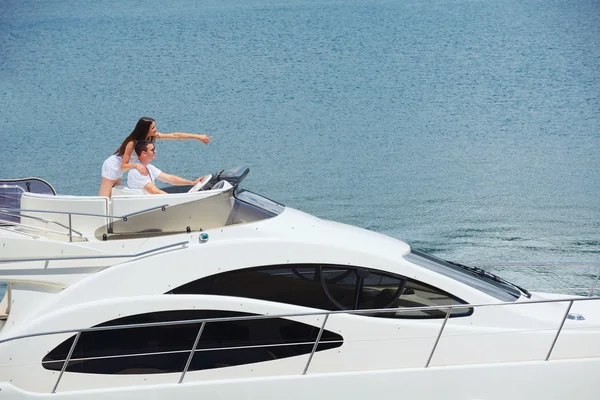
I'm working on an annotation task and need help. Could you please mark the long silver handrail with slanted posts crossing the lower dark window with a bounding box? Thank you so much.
[0,297,600,393]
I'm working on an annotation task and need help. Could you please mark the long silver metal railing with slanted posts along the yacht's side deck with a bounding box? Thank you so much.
[0,297,600,393]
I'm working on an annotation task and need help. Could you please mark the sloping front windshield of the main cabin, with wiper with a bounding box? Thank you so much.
[404,249,530,301]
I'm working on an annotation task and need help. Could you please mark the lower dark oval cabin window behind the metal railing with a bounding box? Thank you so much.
[42,310,343,374]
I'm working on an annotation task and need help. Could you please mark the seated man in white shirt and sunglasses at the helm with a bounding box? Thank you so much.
[127,140,204,194]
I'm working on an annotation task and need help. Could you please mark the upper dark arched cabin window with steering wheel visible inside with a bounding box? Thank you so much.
[168,264,473,318]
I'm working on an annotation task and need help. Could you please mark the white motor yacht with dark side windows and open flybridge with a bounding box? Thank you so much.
[0,168,600,400]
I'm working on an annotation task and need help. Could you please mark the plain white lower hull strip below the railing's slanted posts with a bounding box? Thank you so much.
[0,358,600,400]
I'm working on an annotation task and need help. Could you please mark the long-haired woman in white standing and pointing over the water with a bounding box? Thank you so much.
[98,117,213,197]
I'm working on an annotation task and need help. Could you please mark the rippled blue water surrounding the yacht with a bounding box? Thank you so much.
[0,0,600,286]
